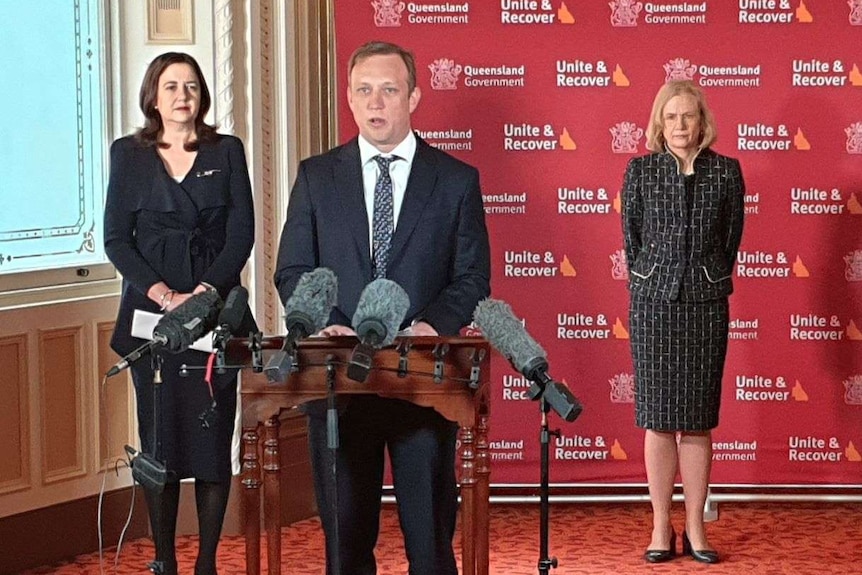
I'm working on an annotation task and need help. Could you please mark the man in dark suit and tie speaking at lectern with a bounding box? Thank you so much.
[275,42,490,575]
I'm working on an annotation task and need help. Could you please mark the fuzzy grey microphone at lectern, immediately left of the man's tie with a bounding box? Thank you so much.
[263,268,338,383]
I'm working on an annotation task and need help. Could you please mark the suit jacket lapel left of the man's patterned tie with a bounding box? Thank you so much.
[333,143,371,274]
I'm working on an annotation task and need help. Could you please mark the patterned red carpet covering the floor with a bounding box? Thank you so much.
[16,503,862,575]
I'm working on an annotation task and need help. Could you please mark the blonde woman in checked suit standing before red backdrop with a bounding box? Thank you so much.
[622,80,745,563]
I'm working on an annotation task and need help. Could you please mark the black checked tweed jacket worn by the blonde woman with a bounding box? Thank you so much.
[622,148,745,301]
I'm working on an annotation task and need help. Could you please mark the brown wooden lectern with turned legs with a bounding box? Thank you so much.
[242,337,491,575]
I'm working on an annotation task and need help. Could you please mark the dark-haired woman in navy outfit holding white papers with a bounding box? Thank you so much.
[105,52,254,575]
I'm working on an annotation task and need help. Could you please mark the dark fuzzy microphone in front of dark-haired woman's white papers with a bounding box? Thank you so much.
[105,290,221,377]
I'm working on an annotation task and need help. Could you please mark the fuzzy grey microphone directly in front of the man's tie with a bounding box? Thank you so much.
[347,278,410,383]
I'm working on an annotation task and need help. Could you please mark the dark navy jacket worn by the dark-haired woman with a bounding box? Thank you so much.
[105,135,254,355]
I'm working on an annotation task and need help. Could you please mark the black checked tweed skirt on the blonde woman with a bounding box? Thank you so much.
[629,294,728,431]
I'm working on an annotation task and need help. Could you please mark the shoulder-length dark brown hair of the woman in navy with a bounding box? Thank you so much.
[135,52,216,150]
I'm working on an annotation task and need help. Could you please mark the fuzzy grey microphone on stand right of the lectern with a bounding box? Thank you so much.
[473,299,583,421]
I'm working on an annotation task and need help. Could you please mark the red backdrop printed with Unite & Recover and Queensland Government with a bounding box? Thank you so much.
[335,0,862,485]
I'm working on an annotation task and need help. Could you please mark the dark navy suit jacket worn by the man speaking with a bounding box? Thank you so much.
[275,137,491,335]
